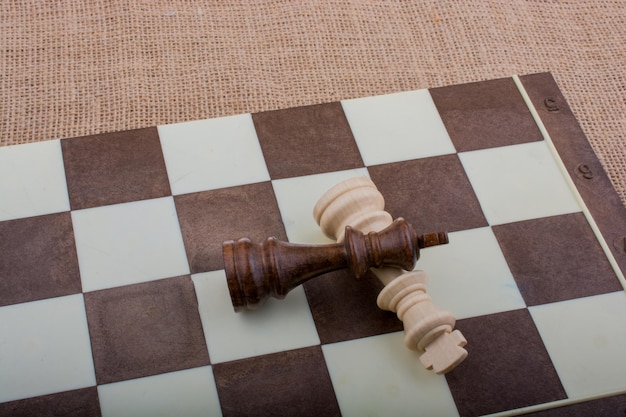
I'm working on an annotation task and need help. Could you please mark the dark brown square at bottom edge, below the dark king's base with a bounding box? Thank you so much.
[213,346,341,417]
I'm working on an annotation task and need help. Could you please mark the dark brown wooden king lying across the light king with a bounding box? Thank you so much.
[223,218,448,311]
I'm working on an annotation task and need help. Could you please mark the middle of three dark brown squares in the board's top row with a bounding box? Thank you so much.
[252,102,363,179]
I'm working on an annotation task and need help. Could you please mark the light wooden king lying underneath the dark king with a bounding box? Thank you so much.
[313,177,467,374]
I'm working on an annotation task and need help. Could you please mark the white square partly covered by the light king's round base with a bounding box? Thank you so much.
[272,168,369,244]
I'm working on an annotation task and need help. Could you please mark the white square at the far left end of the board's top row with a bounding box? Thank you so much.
[0,140,70,221]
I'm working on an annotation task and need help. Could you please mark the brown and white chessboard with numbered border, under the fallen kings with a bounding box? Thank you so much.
[0,73,626,417]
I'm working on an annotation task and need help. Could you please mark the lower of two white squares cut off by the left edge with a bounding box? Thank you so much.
[0,294,96,402]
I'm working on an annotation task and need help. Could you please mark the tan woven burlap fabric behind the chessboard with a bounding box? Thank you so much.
[0,0,626,206]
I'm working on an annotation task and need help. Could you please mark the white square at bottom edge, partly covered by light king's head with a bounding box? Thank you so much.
[322,332,458,417]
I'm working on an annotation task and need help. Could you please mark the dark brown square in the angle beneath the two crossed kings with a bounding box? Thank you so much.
[304,271,403,344]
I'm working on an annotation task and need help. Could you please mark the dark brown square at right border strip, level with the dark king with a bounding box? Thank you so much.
[493,213,622,306]
